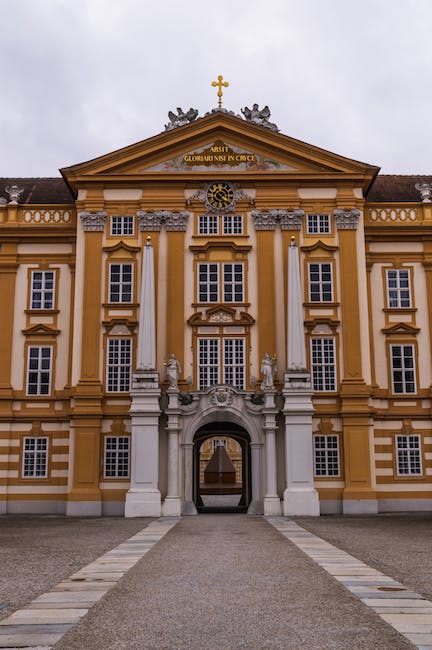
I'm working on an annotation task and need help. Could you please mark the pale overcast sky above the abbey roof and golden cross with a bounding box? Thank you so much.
[0,0,432,176]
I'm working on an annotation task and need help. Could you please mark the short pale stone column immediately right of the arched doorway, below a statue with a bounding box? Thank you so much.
[262,389,281,516]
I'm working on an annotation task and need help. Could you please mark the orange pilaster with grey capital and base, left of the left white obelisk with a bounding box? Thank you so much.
[66,210,106,516]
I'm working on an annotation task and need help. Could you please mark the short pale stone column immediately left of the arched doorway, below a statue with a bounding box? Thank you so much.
[162,388,181,517]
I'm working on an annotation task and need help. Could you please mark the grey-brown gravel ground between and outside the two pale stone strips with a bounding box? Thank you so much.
[0,514,432,650]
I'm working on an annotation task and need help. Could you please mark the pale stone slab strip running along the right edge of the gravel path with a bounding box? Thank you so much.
[266,517,432,650]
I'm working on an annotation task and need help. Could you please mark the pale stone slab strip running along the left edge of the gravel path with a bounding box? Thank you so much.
[0,517,180,650]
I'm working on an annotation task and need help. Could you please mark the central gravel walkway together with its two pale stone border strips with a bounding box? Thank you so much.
[0,515,432,650]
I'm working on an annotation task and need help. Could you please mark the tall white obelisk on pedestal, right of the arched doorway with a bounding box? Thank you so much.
[283,236,319,516]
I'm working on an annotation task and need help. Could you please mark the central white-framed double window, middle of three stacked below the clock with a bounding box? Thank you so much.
[198,262,244,303]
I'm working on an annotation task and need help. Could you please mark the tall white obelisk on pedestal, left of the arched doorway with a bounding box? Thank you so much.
[125,237,161,517]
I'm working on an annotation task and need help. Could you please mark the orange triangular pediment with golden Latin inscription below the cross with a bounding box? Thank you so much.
[61,113,378,186]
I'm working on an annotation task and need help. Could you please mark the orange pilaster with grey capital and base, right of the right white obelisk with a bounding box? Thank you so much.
[334,208,378,514]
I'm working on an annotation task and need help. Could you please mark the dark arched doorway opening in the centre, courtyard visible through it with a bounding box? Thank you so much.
[193,422,252,512]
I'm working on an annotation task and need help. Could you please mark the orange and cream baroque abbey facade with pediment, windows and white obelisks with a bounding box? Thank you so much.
[0,109,432,516]
